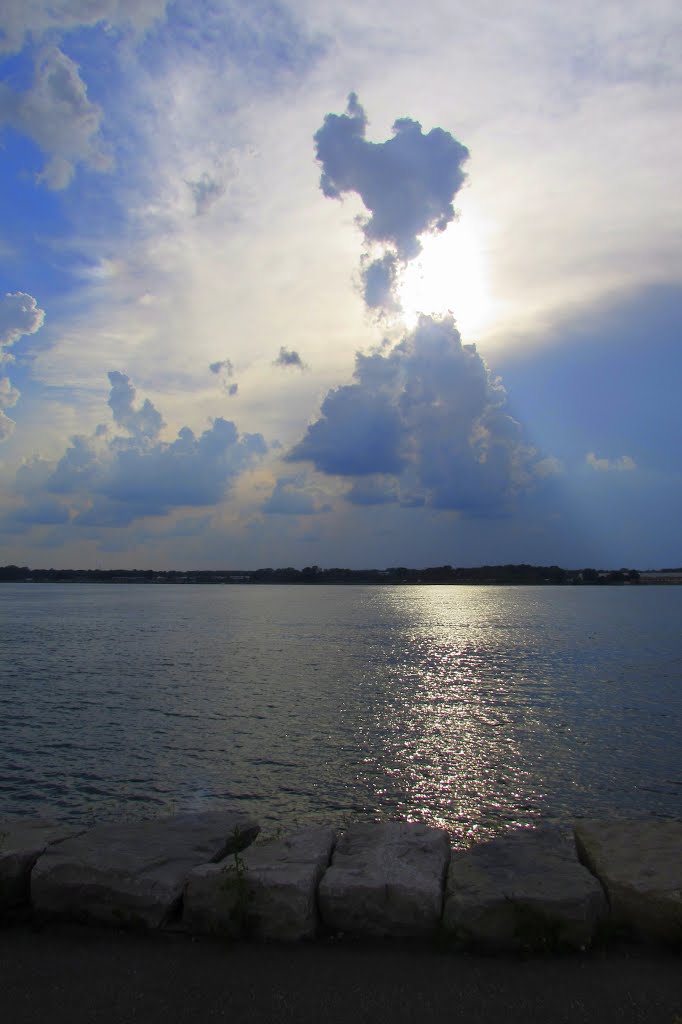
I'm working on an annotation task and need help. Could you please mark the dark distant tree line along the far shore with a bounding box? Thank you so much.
[0,563,647,586]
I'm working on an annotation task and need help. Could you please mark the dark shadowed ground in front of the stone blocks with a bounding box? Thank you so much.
[0,926,682,1024]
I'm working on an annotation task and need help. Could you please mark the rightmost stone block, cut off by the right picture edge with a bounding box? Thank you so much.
[576,818,682,943]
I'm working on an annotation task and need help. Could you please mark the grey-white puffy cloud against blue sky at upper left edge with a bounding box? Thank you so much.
[0,46,112,189]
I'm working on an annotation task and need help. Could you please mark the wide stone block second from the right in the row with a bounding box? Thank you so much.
[442,829,607,949]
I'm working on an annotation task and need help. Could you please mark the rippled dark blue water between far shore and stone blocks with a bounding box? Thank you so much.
[0,584,682,844]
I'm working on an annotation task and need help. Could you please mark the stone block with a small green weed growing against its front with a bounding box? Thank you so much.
[182,827,336,942]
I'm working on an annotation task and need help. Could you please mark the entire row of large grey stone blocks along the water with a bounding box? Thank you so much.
[0,810,682,950]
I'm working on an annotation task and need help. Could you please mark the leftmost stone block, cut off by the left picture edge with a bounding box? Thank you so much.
[0,817,82,912]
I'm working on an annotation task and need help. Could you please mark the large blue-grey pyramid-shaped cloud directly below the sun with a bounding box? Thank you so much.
[286,315,547,516]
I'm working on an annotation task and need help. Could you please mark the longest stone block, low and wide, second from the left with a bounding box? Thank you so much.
[31,810,258,928]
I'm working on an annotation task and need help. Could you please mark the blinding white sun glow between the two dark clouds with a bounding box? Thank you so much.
[397,200,500,341]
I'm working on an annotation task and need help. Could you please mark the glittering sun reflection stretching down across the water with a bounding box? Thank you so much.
[356,587,543,846]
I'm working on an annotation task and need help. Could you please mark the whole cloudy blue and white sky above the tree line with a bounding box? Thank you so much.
[0,0,682,569]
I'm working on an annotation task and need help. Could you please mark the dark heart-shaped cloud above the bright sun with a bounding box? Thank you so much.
[314,92,469,260]
